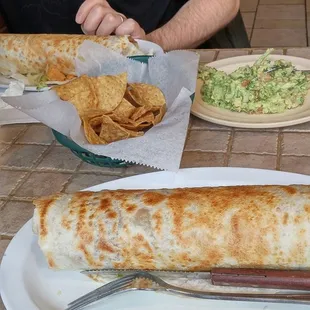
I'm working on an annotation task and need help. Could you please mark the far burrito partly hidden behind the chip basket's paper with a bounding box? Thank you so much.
[0,34,145,86]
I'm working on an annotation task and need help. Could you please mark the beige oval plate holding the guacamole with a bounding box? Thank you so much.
[192,55,310,128]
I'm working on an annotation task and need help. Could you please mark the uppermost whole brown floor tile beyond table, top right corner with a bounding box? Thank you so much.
[256,5,305,19]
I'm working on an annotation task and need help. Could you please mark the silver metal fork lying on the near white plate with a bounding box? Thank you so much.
[66,271,310,310]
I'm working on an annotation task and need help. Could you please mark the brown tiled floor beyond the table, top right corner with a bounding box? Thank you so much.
[240,0,310,47]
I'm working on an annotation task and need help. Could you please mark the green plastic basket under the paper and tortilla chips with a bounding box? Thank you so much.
[52,56,195,168]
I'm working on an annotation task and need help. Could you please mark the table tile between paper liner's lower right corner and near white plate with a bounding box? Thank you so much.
[181,152,225,168]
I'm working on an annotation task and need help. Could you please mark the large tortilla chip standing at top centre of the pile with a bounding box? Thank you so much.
[90,73,127,114]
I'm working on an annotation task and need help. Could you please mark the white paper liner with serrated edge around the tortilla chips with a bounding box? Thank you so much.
[3,41,199,171]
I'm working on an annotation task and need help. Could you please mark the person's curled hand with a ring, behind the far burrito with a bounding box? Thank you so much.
[75,0,145,39]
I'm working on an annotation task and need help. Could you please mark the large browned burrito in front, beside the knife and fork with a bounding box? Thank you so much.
[33,185,310,271]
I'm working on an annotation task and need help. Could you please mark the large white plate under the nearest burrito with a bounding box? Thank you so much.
[0,168,310,310]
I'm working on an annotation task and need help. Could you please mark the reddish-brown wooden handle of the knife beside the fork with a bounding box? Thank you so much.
[211,268,310,290]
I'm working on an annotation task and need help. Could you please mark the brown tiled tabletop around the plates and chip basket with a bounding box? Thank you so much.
[0,48,310,310]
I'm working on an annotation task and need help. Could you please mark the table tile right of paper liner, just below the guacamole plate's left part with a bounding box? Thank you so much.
[185,130,230,152]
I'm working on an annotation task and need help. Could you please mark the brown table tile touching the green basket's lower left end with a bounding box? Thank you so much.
[37,146,81,171]
